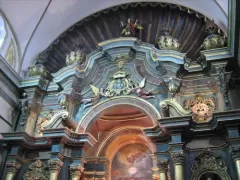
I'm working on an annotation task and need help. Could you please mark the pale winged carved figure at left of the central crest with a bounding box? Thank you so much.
[81,85,106,109]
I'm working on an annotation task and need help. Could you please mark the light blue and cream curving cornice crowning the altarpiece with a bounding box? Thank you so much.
[52,38,185,87]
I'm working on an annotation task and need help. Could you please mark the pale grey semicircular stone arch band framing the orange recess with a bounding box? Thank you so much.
[76,96,161,133]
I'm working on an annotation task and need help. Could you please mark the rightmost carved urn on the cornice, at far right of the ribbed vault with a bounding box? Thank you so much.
[202,21,227,50]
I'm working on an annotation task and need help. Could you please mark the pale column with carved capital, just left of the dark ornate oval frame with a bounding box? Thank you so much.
[171,151,184,180]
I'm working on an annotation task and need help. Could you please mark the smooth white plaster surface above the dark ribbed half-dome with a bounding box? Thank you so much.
[0,0,228,73]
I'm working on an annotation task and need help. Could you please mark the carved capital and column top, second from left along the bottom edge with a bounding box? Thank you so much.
[48,160,63,180]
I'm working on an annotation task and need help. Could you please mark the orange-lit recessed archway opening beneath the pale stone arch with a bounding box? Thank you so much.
[84,104,156,180]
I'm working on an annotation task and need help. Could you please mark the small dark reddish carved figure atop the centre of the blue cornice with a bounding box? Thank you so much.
[120,18,143,36]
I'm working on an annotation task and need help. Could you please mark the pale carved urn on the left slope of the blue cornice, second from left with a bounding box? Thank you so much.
[66,44,86,65]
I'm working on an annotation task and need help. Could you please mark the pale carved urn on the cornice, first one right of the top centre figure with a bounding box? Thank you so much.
[157,28,181,51]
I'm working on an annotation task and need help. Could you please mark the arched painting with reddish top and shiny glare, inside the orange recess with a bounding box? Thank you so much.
[111,144,153,180]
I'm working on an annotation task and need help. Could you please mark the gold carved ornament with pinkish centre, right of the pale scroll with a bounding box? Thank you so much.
[184,95,216,123]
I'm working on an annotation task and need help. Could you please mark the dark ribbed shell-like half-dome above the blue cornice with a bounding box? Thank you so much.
[38,3,218,72]
